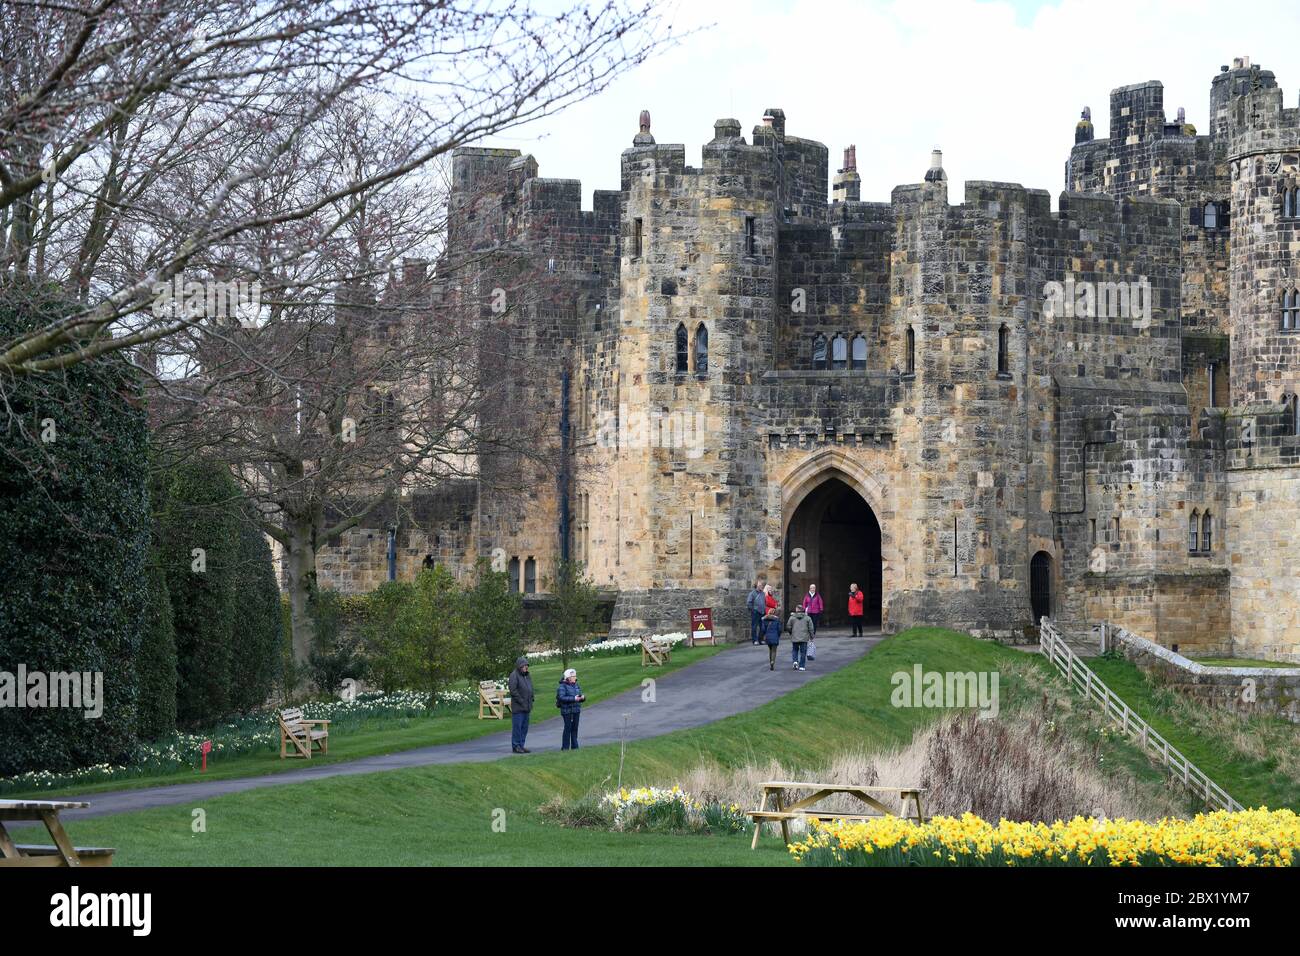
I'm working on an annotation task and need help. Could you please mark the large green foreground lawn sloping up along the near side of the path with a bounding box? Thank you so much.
[22,628,1196,866]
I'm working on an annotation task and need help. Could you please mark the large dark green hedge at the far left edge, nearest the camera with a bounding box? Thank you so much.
[0,293,150,775]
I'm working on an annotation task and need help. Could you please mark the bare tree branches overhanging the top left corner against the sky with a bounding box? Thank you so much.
[0,0,668,375]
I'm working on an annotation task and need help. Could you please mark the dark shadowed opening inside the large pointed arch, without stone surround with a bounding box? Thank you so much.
[783,477,883,627]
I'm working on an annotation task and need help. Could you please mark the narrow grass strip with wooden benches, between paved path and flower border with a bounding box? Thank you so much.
[4,645,724,800]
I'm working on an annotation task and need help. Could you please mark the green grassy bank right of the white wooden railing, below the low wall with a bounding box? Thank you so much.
[1087,657,1300,810]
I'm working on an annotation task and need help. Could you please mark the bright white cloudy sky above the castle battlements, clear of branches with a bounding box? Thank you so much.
[491,0,1300,208]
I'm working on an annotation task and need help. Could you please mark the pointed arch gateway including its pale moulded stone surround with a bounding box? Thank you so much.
[781,449,898,628]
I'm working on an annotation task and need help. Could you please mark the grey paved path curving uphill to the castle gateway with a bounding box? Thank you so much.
[60,635,881,819]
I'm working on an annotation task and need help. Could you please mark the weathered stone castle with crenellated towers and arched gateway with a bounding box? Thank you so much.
[320,59,1300,659]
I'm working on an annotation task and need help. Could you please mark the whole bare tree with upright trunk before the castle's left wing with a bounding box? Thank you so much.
[150,103,564,661]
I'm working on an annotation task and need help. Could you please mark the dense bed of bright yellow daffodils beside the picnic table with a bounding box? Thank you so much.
[790,809,1300,866]
